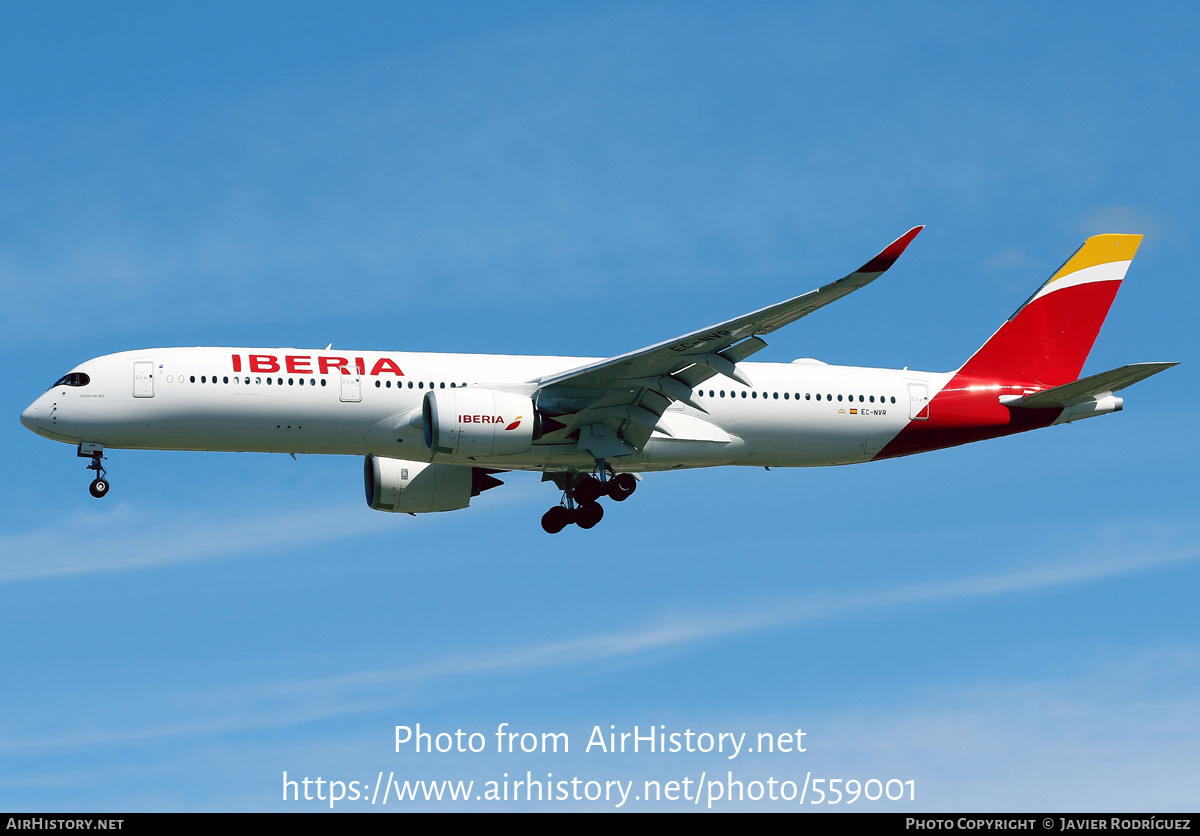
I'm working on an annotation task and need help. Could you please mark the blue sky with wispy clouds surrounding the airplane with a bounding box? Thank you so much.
[0,2,1200,811]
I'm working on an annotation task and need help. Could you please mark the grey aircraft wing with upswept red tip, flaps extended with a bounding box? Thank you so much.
[532,227,924,458]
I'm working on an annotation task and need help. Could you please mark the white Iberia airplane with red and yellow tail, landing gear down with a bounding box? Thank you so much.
[20,227,1177,534]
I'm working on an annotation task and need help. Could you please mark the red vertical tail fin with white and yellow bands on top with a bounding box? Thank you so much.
[959,234,1141,386]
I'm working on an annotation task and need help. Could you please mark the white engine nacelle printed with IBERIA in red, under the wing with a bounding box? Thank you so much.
[421,387,541,458]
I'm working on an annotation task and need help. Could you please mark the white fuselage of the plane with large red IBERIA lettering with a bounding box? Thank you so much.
[22,348,952,471]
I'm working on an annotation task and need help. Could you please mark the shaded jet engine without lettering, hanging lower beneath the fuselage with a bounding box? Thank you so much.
[362,456,504,513]
